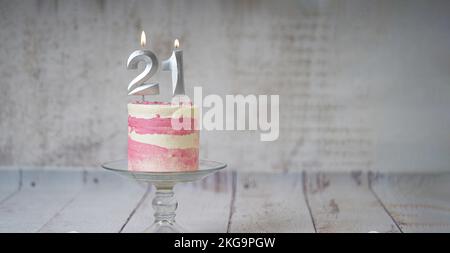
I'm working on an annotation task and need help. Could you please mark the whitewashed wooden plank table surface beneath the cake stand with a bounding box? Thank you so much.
[0,168,450,233]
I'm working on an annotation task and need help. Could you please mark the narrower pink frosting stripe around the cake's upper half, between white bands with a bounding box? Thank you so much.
[128,116,198,135]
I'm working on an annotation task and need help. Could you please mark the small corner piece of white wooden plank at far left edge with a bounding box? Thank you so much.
[0,167,21,204]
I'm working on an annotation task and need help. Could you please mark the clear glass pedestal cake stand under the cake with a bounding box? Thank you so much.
[102,160,227,233]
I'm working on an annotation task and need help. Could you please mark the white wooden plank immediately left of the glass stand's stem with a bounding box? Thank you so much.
[40,168,147,233]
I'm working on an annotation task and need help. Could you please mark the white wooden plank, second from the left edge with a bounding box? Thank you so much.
[0,169,83,232]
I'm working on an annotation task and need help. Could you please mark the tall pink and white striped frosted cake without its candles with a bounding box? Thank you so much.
[128,102,199,171]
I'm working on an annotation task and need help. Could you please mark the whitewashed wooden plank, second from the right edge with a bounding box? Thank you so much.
[304,172,400,233]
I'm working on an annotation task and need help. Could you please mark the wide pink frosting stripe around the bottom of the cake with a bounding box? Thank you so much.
[128,138,199,171]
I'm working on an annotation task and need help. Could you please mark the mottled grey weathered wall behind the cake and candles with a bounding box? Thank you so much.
[0,0,450,171]
